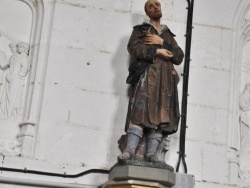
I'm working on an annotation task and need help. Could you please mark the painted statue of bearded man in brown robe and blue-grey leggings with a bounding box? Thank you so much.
[118,0,184,162]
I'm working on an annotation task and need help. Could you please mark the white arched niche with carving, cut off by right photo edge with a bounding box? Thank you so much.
[228,0,250,185]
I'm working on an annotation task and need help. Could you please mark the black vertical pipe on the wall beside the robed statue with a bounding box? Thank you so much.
[176,0,194,173]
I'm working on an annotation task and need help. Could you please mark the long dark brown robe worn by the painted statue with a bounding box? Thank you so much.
[126,23,184,134]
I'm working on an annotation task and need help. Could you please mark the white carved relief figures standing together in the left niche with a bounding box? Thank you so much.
[0,42,30,121]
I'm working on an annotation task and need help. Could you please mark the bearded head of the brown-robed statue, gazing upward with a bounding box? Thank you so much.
[145,0,162,20]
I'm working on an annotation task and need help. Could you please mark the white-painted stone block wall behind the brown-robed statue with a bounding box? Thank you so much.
[0,0,250,188]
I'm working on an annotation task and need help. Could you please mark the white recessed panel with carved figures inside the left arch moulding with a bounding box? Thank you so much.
[0,0,32,155]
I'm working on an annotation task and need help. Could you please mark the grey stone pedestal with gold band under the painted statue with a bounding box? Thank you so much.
[103,164,175,188]
